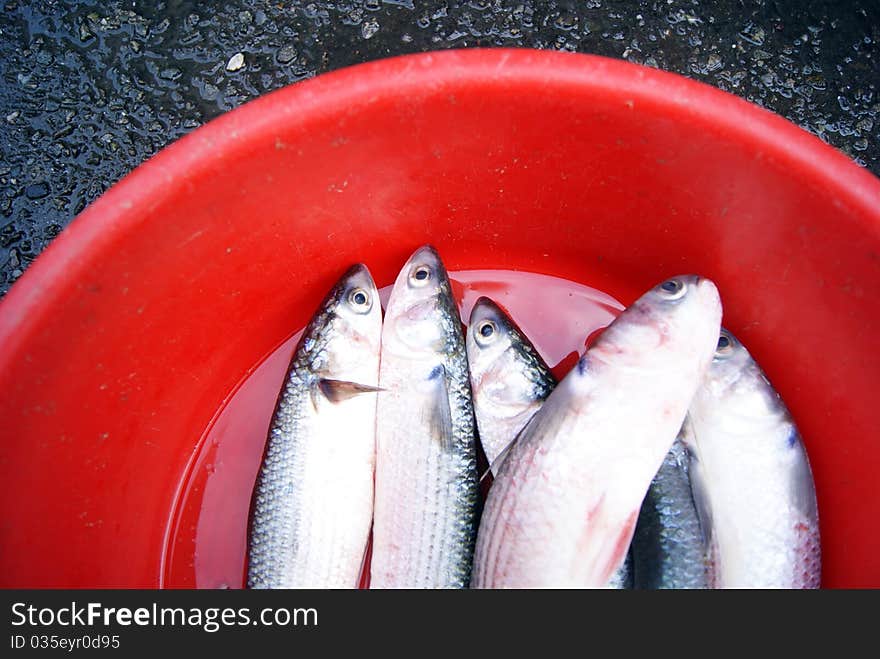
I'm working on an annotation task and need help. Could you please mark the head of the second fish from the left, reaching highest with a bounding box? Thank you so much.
[382,245,461,359]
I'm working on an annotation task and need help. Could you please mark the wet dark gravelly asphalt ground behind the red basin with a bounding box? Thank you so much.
[0,0,880,295]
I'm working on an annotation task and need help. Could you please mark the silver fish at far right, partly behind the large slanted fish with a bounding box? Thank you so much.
[683,330,821,588]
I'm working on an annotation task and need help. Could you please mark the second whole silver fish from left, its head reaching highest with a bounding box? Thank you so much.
[370,246,479,588]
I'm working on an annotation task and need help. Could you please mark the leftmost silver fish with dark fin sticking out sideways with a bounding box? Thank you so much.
[247,265,382,588]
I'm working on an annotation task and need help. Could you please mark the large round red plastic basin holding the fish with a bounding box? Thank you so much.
[0,50,880,587]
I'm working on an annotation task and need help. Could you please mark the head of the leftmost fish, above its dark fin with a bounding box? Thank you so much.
[315,263,382,374]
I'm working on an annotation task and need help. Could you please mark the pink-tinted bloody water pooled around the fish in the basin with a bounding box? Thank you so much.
[162,270,623,588]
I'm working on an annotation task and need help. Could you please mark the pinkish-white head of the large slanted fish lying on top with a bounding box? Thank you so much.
[582,275,721,373]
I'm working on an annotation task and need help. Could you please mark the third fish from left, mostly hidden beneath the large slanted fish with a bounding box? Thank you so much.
[467,297,633,589]
